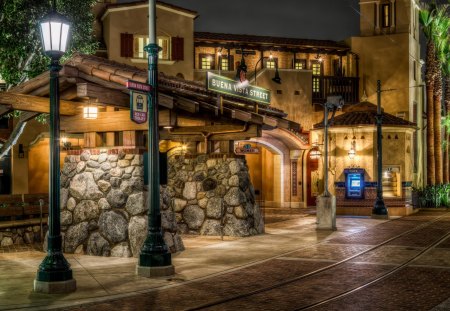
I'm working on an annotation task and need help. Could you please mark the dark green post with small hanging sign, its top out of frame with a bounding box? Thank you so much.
[136,0,175,277]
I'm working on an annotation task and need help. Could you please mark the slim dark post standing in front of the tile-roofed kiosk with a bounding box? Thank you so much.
[372,80,389,219]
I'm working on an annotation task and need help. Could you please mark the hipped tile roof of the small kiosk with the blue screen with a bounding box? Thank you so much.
[314,102,416,128]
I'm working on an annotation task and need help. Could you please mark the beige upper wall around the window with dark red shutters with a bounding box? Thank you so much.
[102,4,195,80]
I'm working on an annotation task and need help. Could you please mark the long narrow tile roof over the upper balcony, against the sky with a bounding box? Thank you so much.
[194,32,350,50]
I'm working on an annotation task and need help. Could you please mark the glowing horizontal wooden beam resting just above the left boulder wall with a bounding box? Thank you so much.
[61,110,170,133]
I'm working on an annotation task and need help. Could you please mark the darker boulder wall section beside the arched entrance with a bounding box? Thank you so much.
[167,155,264,236]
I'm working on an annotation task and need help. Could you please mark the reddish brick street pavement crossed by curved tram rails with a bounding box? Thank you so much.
[64,212,450,311]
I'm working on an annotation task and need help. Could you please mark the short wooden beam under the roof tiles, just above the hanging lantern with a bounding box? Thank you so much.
[77,83,130,108]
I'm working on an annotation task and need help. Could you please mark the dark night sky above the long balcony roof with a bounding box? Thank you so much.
[119,0,359,41]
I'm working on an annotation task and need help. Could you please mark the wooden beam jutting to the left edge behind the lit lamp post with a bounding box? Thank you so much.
[0,92,79,116]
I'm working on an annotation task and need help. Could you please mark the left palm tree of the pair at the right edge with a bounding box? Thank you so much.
[419,4,436,185]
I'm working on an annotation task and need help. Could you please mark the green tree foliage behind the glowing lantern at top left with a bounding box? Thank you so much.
[0,0,97,88]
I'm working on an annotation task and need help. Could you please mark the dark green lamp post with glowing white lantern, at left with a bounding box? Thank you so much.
[34,0,76,294]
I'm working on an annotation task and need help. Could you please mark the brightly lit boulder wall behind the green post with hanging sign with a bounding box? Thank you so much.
[61,149,184,257]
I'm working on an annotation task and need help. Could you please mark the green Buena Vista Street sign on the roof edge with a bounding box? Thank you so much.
[206,72,270,105]
